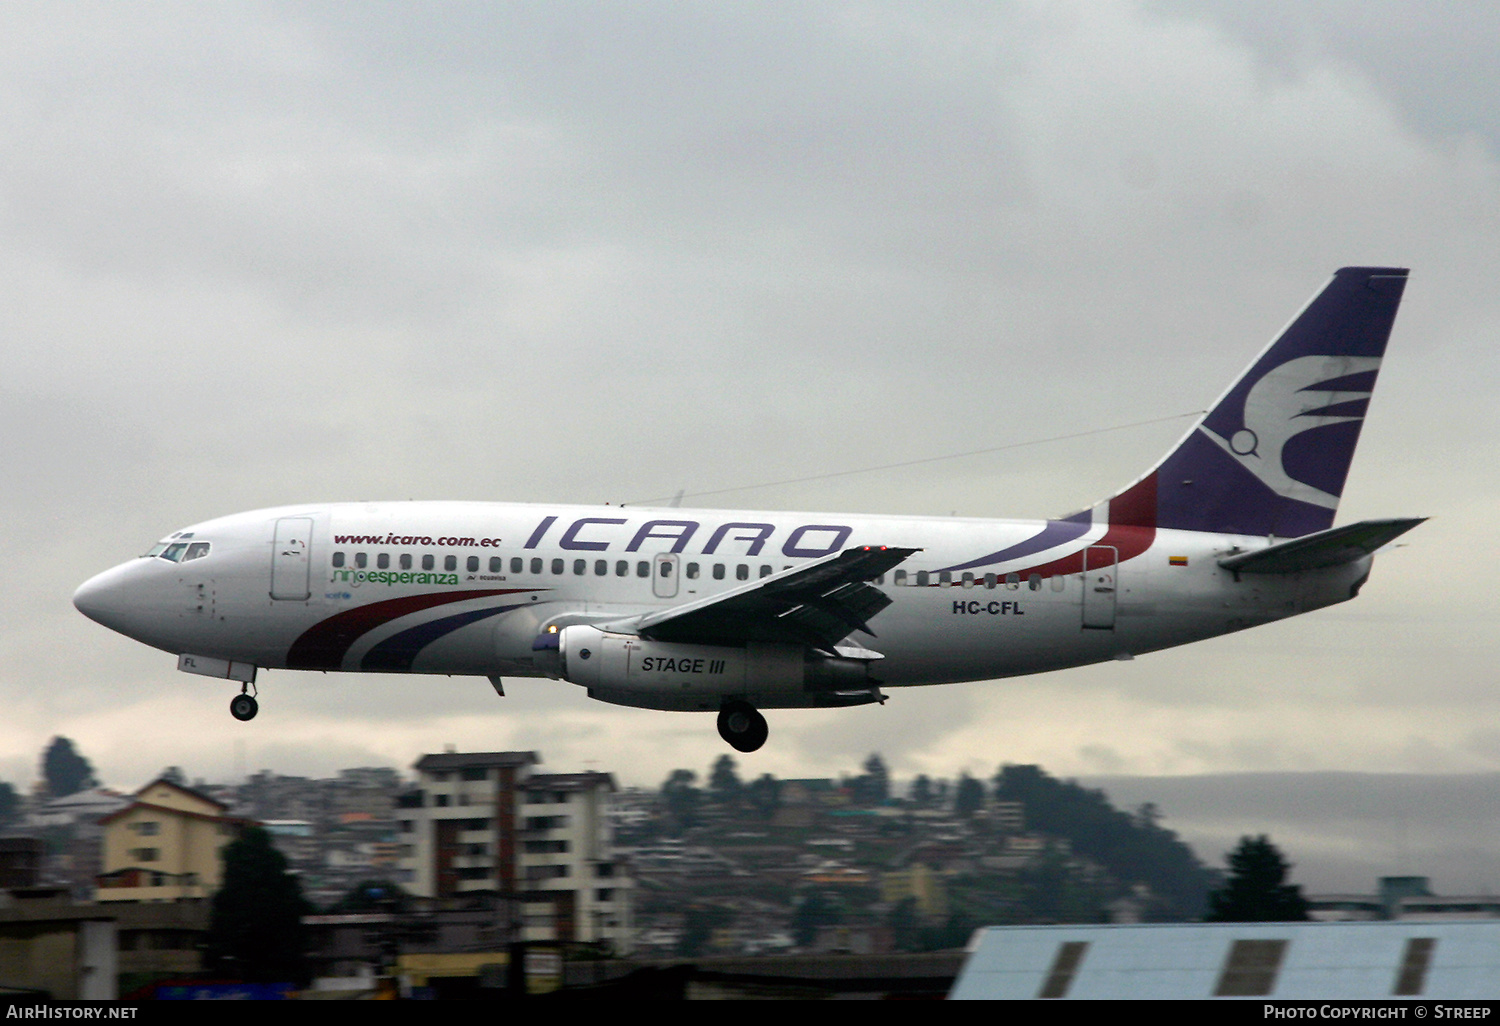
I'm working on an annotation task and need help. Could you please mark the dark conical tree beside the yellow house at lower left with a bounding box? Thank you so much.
[206,827,311,983]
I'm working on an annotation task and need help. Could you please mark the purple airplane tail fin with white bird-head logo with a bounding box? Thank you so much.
[1095,267,1407,539]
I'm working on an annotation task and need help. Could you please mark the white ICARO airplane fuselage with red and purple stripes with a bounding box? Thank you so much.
[77,503,1370,708]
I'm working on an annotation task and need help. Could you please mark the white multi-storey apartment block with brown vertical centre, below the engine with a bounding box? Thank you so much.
[396,752,635,953]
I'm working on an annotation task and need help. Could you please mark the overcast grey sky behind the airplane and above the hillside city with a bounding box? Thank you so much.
[0,0,1500,888]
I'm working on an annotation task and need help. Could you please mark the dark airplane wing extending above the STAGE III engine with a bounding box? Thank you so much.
[602,545,921,651]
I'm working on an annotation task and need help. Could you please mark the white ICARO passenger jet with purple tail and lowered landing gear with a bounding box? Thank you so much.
[74,267,1424,752]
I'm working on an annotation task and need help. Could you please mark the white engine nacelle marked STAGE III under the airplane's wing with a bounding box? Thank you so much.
[558,624,876,705]
